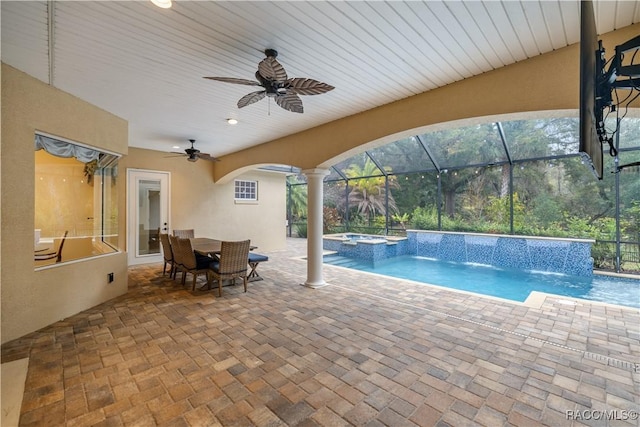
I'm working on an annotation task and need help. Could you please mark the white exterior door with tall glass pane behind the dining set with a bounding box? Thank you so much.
[127,169,171,265]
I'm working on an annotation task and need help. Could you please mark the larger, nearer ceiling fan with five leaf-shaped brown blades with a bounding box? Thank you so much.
[205,49,334,113]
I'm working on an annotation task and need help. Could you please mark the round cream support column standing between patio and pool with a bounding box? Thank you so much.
[302,169,329,288]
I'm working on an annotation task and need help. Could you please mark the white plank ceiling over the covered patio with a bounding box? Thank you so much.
[0,0,640,156]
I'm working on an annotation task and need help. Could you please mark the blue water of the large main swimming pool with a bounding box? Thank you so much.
[324,255,640,308]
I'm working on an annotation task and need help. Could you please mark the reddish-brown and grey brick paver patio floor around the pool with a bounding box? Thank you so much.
[1,239,640,427]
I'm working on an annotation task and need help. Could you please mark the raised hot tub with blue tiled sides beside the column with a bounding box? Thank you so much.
[322,233,407,263]
